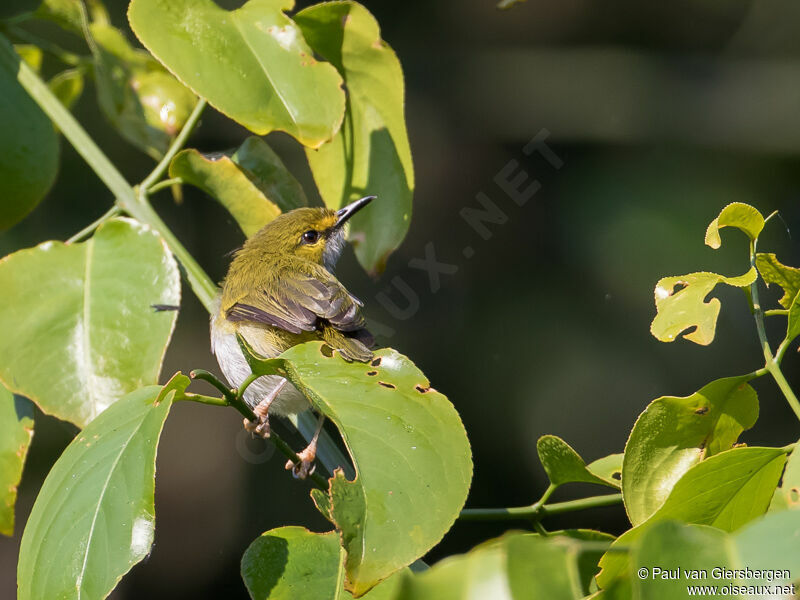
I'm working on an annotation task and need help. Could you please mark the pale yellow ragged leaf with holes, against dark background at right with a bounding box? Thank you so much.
[650,267,758,346]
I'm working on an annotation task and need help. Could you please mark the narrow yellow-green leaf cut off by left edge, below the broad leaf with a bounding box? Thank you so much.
[0,385,33,536]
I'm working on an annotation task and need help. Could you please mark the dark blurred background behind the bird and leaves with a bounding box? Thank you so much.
[0,0,800,599]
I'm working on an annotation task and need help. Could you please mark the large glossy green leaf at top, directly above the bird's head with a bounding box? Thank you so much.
[128,0,344,148]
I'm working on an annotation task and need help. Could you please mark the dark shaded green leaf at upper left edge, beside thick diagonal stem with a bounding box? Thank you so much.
[0,40,59,231]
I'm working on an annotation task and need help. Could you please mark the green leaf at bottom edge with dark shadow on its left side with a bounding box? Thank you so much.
[242,527,402,600]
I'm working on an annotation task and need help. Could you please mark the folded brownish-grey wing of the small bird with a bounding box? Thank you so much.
[226,263,365,333]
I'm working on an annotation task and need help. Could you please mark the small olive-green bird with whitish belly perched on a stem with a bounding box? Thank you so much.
[211,196,374,477]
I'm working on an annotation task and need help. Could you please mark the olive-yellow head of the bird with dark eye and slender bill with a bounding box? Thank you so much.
[242,196,375,271]
